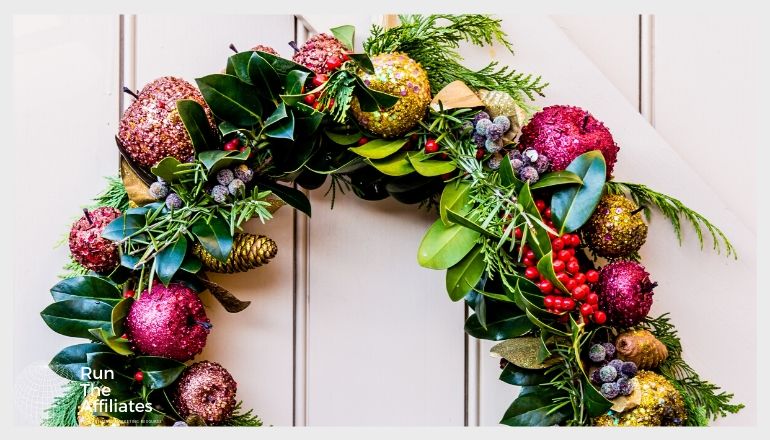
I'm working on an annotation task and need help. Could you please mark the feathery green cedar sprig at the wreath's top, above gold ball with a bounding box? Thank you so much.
[364,14,548,110]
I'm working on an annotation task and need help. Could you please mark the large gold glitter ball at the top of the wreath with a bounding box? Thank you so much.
[350,52,431,138]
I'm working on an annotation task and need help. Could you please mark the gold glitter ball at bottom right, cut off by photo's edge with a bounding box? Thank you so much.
[592,370,687,426]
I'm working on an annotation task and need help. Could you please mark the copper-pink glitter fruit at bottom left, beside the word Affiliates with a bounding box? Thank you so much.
[172,361,238,424]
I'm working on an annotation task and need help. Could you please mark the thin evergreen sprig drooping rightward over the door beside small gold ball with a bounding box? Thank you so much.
[606,181,738,259]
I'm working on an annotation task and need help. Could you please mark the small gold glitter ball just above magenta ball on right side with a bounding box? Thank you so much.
[582,194,647,258]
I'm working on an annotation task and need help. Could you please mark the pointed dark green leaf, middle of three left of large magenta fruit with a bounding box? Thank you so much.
[40,298,112,339]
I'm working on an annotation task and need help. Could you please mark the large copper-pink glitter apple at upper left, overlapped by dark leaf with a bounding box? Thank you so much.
[118,76,216,167]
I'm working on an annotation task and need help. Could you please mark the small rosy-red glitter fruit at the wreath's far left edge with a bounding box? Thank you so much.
[69,206,120,273]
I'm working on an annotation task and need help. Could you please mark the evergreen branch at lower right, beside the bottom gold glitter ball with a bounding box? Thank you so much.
[640,313,744,426]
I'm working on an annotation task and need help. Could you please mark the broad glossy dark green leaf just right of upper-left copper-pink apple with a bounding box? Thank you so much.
[195,73,262,127]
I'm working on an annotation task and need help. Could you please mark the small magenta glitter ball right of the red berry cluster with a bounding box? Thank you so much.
[597,261,657,327]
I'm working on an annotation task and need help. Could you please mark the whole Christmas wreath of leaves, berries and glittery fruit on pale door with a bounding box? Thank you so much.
[41,15,742,426]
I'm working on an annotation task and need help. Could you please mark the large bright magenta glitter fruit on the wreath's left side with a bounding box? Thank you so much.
[126,283,211,362]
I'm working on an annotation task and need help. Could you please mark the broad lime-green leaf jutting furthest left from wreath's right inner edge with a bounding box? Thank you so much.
[417,219,480,269]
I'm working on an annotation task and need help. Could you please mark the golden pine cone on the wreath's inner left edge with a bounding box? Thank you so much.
[193,232,278,273]
